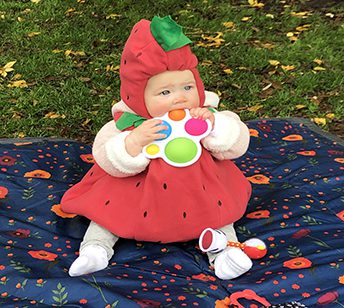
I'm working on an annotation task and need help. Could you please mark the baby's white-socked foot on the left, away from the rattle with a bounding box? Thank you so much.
[68,245,109,277]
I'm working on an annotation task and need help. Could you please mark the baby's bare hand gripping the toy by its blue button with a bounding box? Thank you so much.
[125,119,167,157]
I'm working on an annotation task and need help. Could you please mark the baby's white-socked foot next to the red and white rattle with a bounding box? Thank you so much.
[214,247,252,280]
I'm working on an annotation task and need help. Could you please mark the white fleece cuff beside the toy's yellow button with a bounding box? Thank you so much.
[105,131,150,175]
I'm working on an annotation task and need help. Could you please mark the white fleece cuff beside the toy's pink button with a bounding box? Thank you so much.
[202,112,240,153]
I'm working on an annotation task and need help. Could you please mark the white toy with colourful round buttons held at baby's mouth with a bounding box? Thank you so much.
[142,109,211,167]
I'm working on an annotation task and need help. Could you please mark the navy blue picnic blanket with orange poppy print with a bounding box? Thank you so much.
[0,119,344,307]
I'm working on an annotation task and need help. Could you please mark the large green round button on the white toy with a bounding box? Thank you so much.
[165,137,197,164]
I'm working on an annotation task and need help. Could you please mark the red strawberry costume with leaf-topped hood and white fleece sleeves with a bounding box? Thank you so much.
[61,17,251,278]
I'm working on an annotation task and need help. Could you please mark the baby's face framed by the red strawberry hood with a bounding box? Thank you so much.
[144,70,199,118]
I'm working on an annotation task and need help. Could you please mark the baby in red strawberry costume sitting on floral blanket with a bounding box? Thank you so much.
[61,17,252,279]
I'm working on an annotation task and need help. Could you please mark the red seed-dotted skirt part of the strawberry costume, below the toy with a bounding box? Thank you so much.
[61,149,251,243]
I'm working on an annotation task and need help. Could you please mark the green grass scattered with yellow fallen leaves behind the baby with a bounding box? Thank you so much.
[0,0,344,142]
